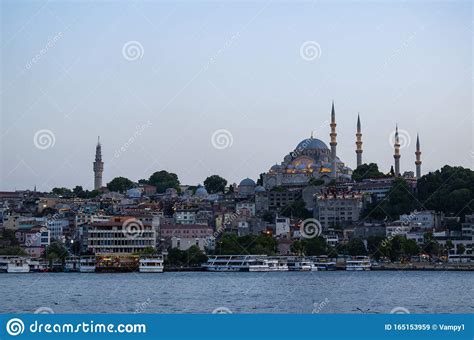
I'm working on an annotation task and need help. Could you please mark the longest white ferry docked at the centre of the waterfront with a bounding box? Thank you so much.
[203,255,270,272]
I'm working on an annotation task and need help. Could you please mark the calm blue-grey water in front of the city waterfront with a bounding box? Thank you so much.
[0,271,474,313]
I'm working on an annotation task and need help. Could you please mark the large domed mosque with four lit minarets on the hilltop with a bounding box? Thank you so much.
[263,102,421,190]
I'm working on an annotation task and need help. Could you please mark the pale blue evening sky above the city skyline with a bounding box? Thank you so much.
[0,0,474,191]
